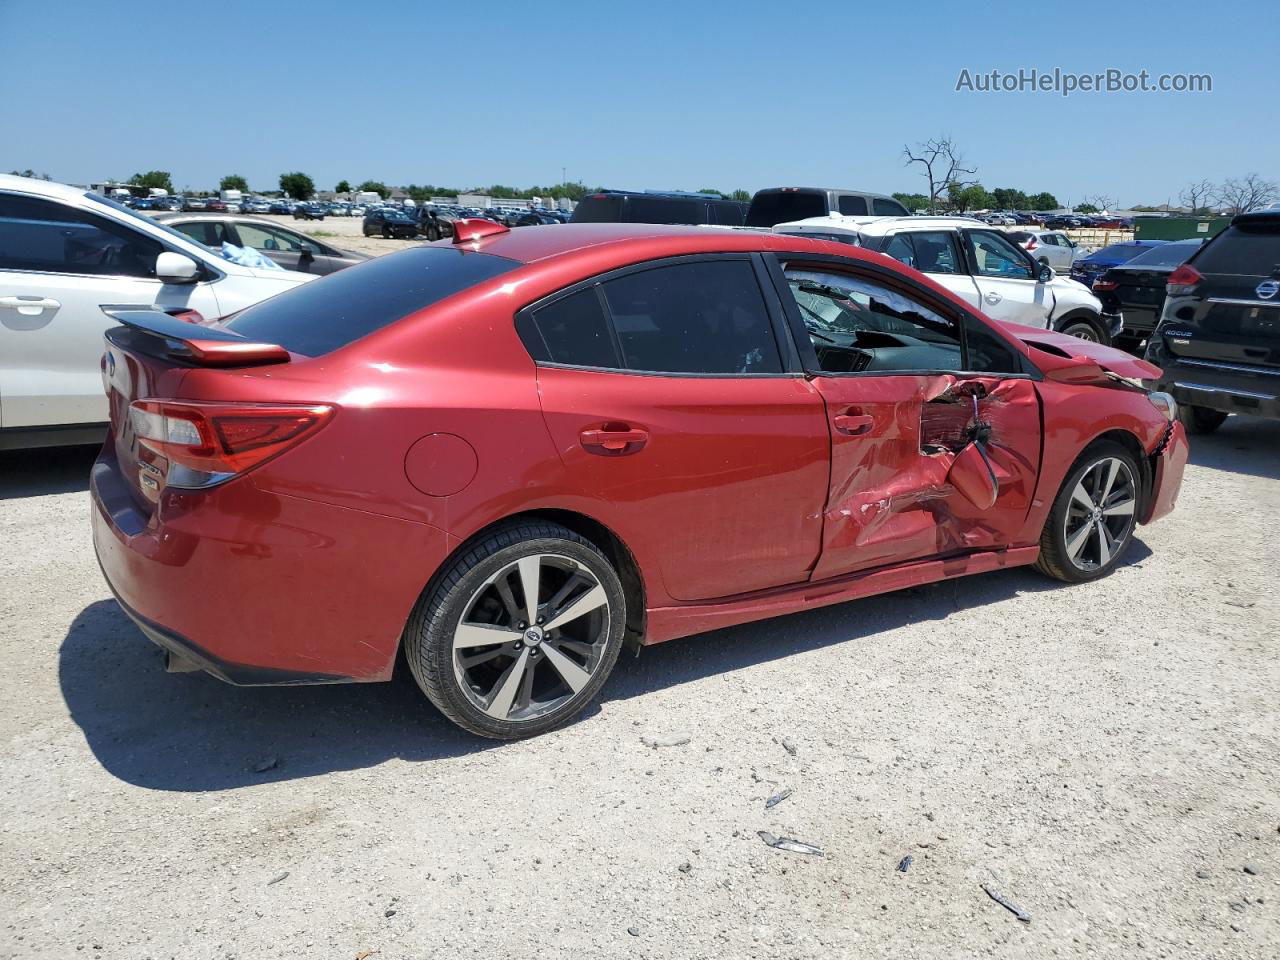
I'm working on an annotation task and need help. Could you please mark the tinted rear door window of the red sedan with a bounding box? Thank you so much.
[604,260,782,374]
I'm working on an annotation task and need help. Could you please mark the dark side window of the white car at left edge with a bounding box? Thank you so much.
[0,193,164,278]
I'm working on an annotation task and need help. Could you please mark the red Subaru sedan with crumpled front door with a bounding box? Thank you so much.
[92,220,1188,737]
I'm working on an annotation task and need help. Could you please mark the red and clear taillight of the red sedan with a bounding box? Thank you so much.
[129,399,333,489]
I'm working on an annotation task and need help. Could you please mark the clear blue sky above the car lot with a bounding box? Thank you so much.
[0,0,1280,205]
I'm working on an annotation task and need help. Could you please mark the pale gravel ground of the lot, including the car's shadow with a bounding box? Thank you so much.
[0,417,1280,960]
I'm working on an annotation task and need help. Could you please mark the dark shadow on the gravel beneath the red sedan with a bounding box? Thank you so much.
[59,552,1149,791]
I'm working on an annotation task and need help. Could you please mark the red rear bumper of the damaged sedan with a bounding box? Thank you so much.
[90,443,448,685]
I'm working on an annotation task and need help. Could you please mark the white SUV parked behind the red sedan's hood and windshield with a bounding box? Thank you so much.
[773,215,1124,344]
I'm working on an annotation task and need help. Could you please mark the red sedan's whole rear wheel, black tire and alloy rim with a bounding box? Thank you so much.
[404,522,626,740]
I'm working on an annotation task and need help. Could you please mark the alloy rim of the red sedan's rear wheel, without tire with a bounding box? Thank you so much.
[452,553,612,722]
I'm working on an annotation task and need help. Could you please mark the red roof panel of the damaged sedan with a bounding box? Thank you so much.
[448,223,879,264]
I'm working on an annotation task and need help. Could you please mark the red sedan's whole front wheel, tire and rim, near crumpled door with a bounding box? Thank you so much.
[1036,440,1142,584]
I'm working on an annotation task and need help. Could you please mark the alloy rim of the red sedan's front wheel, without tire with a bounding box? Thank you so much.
[1064,457,1138,571]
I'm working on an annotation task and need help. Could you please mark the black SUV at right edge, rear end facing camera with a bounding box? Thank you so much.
[1147,210,1280,433]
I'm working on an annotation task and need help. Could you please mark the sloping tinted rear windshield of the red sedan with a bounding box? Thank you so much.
[227,247,520,357]
